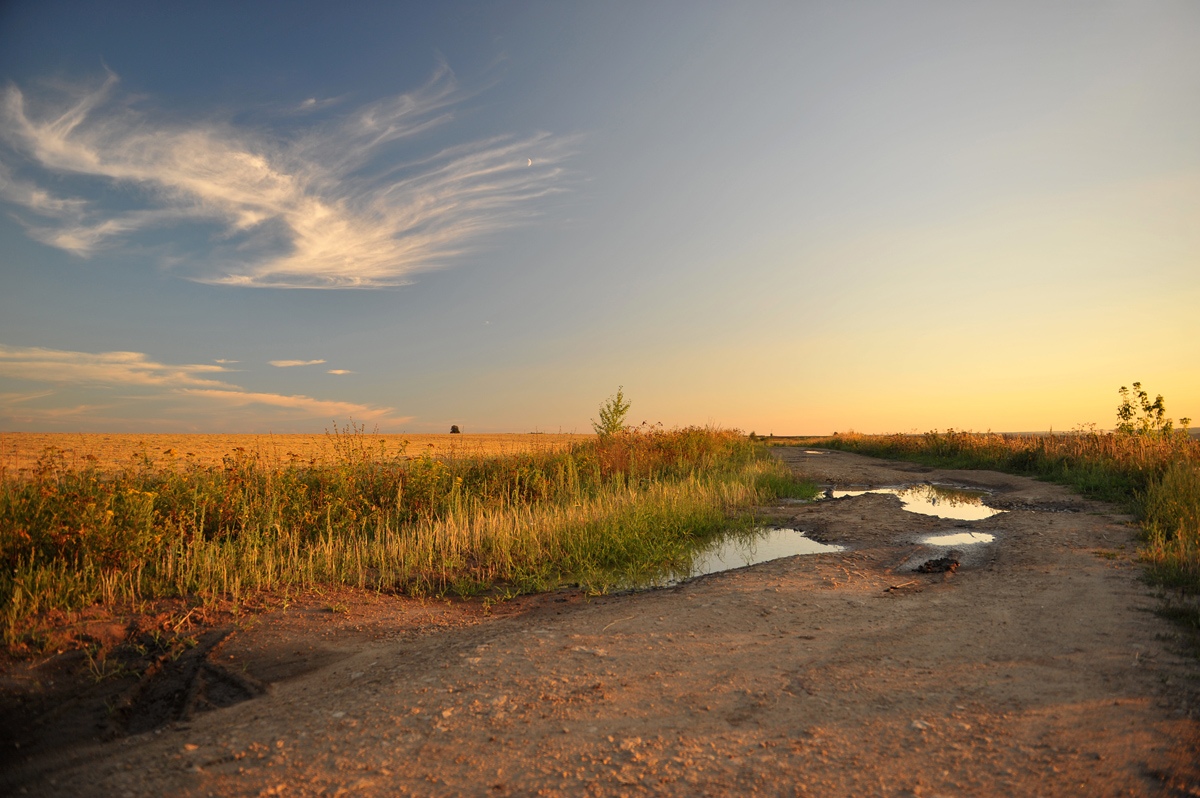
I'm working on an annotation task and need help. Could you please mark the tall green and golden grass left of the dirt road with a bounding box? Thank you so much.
[0,428,815,644]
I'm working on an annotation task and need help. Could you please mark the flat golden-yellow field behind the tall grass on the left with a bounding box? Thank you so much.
[0,432,592,476]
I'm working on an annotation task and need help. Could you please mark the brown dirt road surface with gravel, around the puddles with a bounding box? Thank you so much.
[7,449,1200,796]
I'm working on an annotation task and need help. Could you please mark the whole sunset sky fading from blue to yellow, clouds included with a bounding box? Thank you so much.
[0,0,1200,434]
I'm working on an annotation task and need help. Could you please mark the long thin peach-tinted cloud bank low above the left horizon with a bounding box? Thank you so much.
[0,344,400,427]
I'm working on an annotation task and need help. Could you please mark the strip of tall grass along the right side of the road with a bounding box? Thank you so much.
[821,430,1200,593]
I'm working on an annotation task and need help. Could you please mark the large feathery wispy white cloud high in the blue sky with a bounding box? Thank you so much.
[0,65,571,288]
